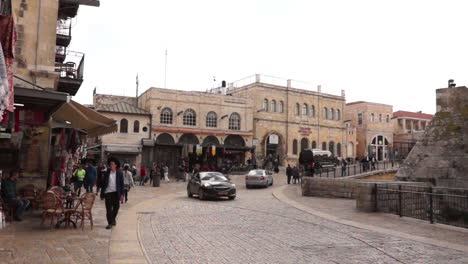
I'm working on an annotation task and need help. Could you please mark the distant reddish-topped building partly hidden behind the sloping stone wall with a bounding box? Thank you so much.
[392,111,433,157]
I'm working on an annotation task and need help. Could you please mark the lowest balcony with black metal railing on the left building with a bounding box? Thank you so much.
[55,51,84,95]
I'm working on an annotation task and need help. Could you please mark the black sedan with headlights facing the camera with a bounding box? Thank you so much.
[187,171,236,200]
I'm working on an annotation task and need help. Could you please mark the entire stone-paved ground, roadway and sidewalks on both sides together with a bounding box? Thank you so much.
[0,172,468,263]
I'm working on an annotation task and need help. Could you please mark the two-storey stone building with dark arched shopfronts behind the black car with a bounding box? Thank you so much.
[138,88,254,173]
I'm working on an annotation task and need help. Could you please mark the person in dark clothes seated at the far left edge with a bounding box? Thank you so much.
[2,171,30,222]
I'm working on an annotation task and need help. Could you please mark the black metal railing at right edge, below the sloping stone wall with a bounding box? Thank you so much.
[374,184,468,228]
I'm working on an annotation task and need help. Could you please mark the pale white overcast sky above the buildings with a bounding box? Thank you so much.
[70,0,468,114]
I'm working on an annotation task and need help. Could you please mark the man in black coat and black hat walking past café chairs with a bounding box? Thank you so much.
[101,158,124,229]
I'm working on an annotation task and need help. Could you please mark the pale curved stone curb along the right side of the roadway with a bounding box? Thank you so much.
[273,186,468,252]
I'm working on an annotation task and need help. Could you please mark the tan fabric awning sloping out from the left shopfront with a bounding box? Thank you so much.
[52,101,117,137]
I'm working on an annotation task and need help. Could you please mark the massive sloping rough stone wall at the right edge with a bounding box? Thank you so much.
[397,87,468,188]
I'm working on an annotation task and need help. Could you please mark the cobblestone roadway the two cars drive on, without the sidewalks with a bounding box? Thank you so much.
[134,173,468,263]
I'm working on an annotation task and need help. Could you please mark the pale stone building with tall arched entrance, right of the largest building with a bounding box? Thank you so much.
[345,101,393,160]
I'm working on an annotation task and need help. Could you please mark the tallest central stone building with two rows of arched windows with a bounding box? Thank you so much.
[223,74,346,165]
